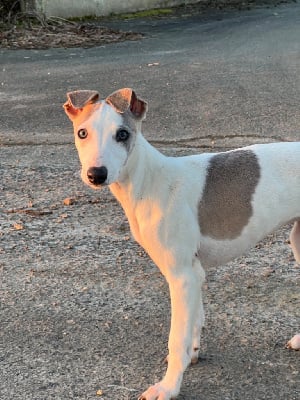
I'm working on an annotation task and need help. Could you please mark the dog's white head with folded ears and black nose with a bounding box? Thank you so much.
[64,88,147,189]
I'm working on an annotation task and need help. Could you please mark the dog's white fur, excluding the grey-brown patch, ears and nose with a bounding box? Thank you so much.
[65,90,300,400]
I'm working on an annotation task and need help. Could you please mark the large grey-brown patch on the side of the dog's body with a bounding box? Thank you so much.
[198,150,260,240]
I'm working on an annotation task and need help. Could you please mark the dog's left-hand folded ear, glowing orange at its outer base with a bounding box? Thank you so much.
[64,90,99,121]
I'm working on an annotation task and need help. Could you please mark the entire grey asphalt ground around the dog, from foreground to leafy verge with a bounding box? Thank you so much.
[0,3,300,400]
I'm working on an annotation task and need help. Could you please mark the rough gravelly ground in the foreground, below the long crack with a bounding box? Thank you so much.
[0,145,300,400]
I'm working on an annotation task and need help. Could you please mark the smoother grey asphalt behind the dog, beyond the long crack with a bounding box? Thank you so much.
[0,3,300,146]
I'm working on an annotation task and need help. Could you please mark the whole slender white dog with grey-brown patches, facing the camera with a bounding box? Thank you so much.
[64,89,300,400]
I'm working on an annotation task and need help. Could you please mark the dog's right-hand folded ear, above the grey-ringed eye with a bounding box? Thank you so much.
[105,88,148,120]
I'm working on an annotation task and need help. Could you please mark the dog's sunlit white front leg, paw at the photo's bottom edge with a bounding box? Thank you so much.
[139,266,201,400]
